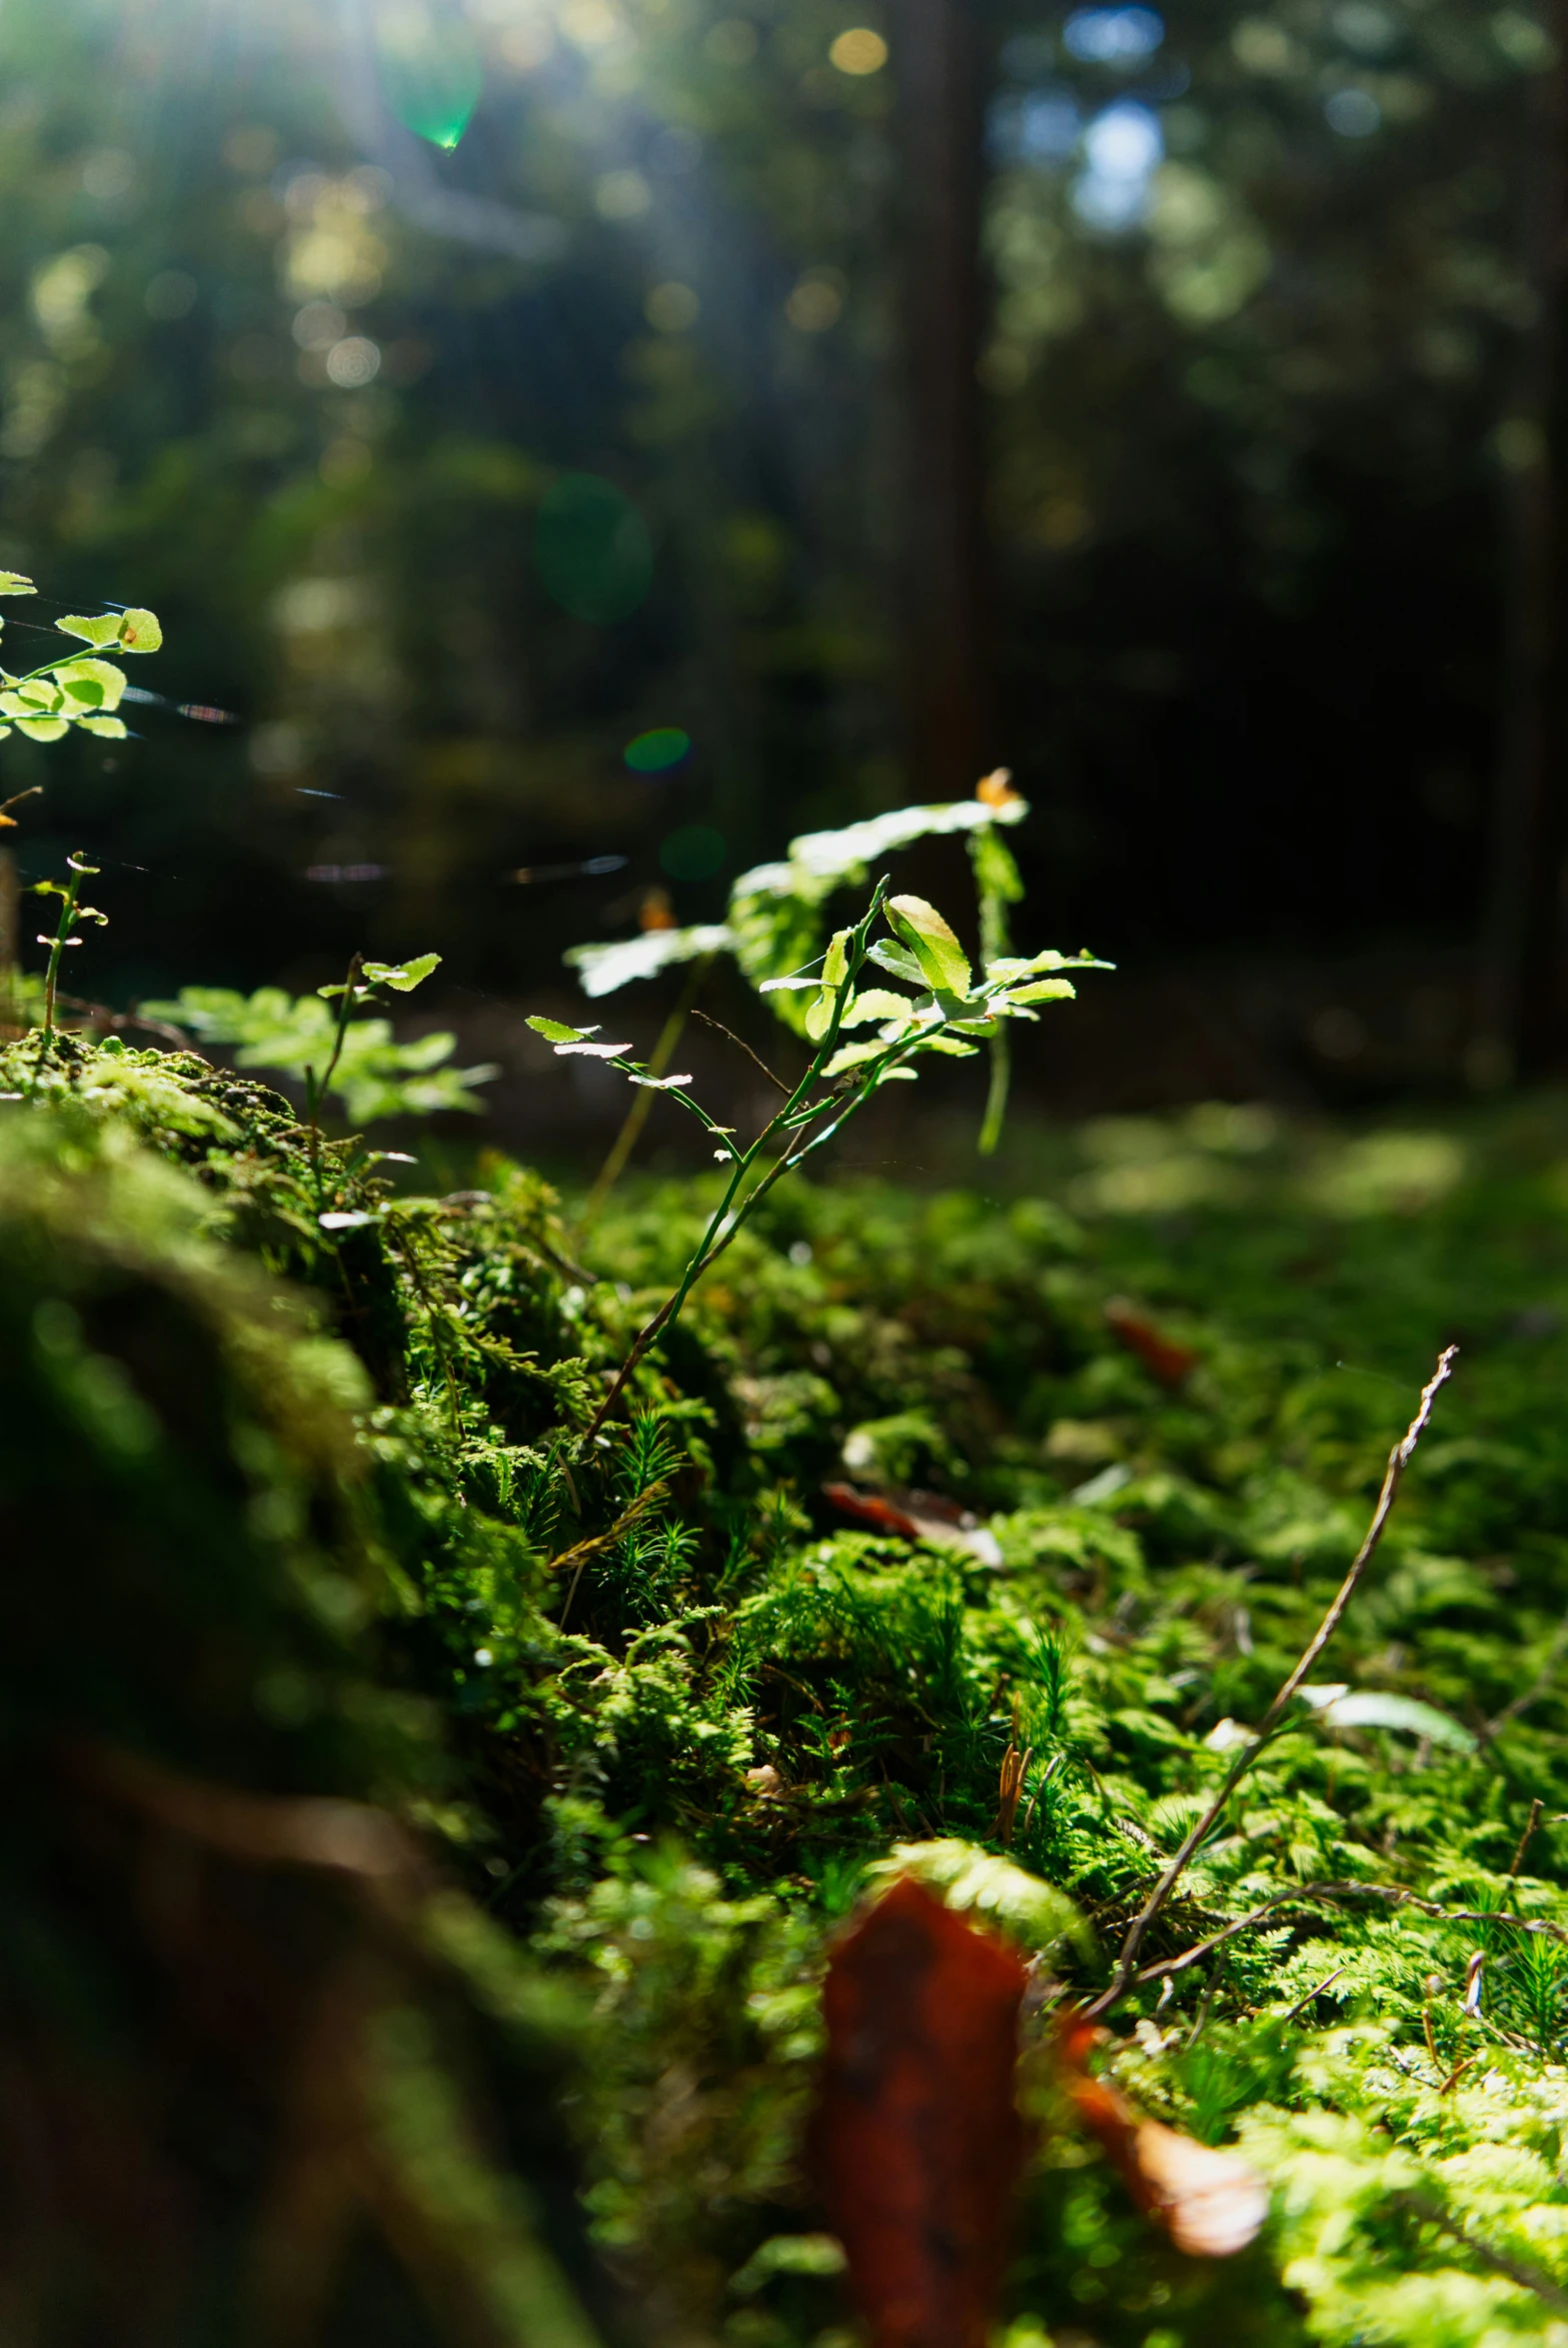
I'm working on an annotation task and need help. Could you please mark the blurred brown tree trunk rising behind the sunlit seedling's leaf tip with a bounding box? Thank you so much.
[892,0,995,799]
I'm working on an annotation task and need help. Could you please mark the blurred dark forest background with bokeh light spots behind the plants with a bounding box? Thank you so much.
[0,0,1561,1092]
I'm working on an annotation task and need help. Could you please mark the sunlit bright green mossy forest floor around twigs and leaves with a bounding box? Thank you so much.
[0,1041,1568,2348]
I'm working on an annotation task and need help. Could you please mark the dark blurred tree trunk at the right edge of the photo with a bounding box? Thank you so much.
[1474,13,1568,1083]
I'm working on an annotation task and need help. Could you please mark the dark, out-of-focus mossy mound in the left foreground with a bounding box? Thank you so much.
[0,1104,597,2348]
